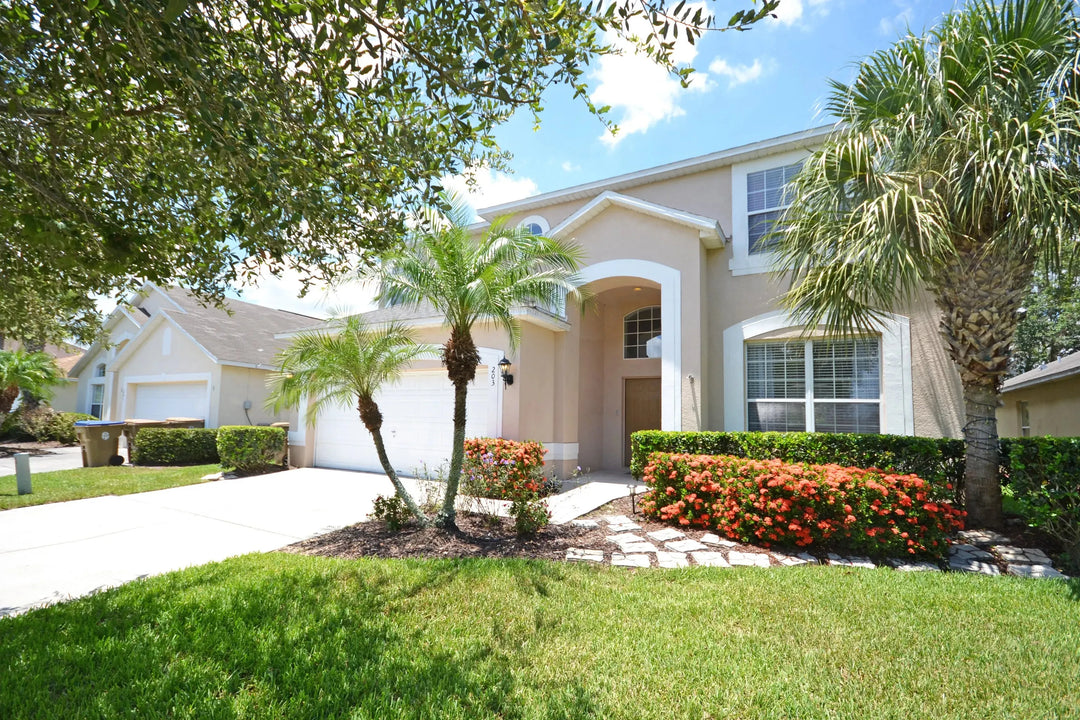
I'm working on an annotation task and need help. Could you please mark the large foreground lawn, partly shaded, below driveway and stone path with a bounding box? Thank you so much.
[0,554,1080,720]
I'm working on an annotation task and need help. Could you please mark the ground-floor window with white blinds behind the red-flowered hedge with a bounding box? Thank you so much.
[746,338,881,433]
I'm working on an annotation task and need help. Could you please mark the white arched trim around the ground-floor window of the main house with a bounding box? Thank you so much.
[724,310,915,435]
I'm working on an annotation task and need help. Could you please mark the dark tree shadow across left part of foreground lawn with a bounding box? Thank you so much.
[0,559,605,718]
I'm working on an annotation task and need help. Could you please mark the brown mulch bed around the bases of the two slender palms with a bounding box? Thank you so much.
[282,498,779,565]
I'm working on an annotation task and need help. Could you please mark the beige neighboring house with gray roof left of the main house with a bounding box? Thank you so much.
[71,284,316,427]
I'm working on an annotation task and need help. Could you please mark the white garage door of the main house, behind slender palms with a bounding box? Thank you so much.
[314,366,499,475]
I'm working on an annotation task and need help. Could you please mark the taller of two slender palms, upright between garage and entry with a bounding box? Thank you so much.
[378,198,583,528]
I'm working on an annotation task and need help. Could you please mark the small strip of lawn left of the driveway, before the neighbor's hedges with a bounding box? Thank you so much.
[0,465,221,509]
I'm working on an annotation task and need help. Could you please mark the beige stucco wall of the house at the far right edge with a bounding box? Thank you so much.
[998,375,1080,437]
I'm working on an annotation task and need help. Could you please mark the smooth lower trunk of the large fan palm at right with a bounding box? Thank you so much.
[963,383,1004,528]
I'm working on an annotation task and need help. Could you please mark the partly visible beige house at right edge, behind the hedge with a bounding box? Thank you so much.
[998,352,1080,437]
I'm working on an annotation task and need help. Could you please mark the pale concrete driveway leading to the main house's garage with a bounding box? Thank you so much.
[0,468,393,616]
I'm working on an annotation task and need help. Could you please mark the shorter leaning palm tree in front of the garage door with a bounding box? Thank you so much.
[268,315,436,525]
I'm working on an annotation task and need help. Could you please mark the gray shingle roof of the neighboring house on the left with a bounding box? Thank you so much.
[162,287,319,368]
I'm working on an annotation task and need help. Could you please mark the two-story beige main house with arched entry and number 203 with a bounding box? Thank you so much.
[292,127,962,473]
